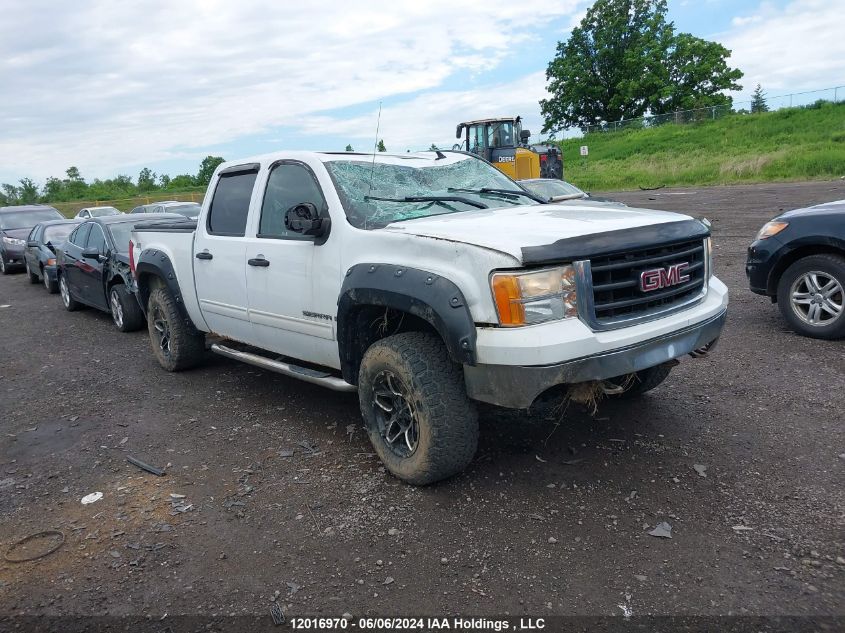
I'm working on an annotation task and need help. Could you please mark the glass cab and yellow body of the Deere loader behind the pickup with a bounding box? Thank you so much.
[455,117,540,179]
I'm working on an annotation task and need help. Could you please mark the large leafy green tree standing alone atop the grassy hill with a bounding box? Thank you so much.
[540,0,742,133]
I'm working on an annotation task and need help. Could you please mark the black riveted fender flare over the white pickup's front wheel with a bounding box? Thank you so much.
[337,263,476,384]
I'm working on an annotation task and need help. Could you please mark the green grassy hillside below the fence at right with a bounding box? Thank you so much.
[561,102,845,191]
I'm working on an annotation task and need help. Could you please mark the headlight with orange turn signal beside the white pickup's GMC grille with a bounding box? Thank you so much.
[490,266,578,327]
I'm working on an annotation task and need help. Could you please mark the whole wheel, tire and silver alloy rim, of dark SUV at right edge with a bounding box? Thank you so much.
[778,255,845,339]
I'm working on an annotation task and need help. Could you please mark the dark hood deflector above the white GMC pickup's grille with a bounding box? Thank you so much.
[522,220,710,266]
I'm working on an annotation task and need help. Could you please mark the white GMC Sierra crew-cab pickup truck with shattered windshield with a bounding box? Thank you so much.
[130,151,728,484]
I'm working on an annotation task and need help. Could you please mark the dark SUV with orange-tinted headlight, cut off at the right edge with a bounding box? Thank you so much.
[745,200,845,339]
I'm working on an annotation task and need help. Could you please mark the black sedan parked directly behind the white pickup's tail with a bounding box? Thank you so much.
[56,215,170,332]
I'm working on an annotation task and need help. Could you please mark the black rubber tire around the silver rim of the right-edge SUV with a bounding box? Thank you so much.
[778,255,845,340]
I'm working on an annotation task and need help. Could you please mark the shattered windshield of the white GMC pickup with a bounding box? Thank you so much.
[325,153,535,229]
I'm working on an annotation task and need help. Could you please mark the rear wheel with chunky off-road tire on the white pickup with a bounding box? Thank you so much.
[147,286,205,371]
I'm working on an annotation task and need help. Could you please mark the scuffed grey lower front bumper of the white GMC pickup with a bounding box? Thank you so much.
[464,308,727,409]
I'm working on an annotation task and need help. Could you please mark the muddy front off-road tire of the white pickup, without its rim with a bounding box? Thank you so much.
[358,332,478,486]
